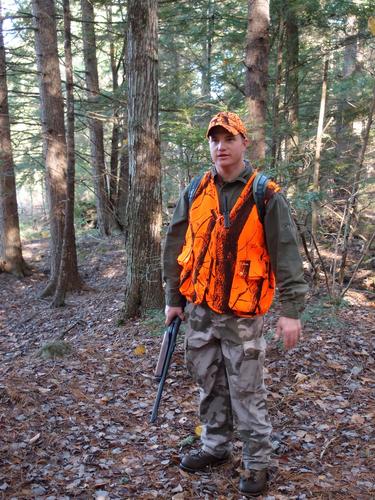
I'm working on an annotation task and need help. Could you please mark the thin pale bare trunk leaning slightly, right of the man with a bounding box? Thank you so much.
[311,59,328,255]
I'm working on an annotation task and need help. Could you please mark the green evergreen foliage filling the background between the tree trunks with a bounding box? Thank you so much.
[0,0,375,296]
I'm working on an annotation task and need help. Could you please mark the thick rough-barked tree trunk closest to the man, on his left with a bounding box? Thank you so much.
[123,0,163,318]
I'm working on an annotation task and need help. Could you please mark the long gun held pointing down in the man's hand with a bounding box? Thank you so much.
[150,316,181,423]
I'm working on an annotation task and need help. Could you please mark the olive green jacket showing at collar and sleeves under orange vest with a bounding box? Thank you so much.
[163,165,307,319]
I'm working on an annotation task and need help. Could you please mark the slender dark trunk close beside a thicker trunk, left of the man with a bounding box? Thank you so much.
[52,0,83,307]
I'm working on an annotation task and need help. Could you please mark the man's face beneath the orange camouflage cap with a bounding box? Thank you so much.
[209,127,248,174]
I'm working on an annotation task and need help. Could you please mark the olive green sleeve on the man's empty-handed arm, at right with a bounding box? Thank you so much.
[264,193,308,319]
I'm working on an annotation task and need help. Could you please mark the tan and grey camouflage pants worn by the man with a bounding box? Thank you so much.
[185,303,272,469]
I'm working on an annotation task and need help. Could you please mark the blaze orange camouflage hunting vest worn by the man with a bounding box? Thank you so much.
[177,168,280,317]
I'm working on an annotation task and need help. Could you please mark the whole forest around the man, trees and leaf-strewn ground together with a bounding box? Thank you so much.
[0,0,375,500]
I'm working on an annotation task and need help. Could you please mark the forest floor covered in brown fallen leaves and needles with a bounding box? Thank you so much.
[0,237,375,500]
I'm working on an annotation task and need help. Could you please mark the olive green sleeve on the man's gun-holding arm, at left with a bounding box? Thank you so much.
[163,188,189,307]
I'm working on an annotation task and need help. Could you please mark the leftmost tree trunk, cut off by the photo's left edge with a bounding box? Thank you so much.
[0,1,30,277]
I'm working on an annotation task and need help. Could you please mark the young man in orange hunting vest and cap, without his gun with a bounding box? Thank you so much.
[163,112,307,496]
